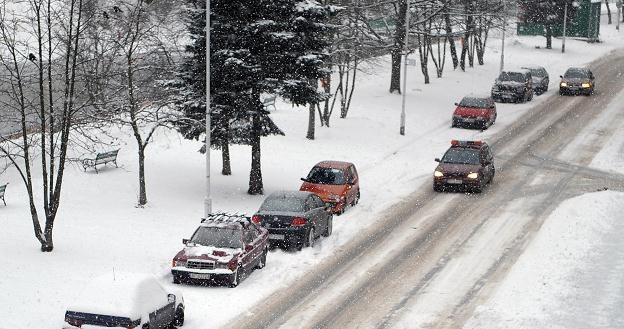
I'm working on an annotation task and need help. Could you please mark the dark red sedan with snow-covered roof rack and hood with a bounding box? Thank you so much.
[171,214,269,288]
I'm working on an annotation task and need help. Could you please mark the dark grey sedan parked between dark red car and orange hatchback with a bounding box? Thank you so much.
[251,191,333,249]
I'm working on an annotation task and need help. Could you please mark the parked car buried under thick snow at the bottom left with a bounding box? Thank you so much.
[63,273,184,329]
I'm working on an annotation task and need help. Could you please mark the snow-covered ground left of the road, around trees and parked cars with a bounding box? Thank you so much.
[0,7,624,329]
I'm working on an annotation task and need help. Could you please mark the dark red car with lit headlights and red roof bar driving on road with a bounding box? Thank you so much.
[433,140,495,193]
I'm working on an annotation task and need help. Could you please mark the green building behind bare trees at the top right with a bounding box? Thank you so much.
[517,0,601,40]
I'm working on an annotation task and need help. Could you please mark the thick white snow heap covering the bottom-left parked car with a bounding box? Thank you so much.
[67,272,168,320]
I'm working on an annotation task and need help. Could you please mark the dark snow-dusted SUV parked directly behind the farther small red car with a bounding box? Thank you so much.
[492,70,533,103]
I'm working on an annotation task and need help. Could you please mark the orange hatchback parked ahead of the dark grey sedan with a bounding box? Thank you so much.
[299,161,360,215]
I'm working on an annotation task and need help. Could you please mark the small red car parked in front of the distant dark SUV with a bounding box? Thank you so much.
[451,96,496,129]
